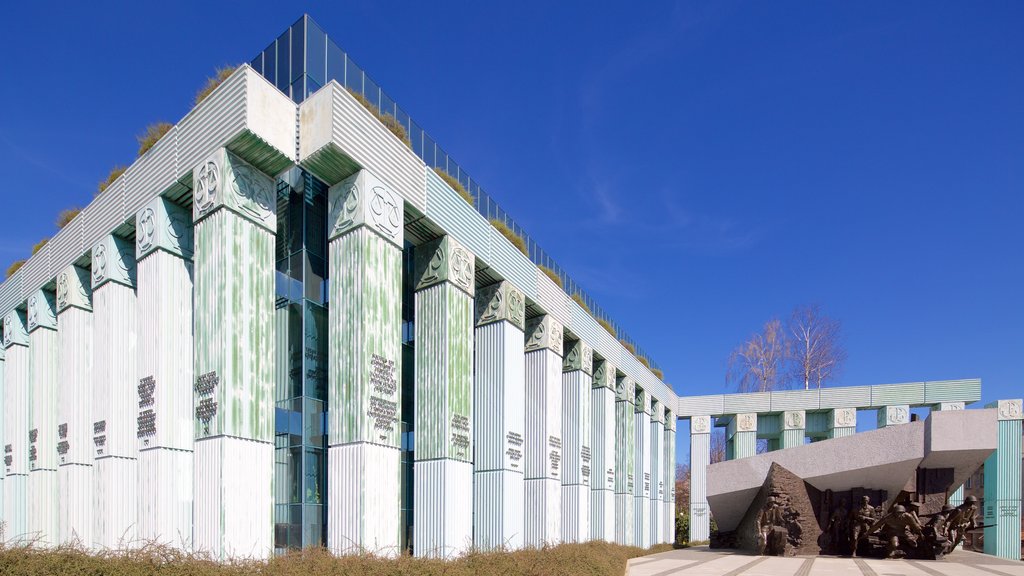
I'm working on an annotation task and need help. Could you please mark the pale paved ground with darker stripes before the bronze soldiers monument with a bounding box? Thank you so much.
[626,546,1024,576]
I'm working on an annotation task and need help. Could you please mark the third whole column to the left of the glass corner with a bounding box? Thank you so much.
[92,236,138,548]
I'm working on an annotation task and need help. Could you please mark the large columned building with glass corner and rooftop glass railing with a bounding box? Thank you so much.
[0,16,677,558]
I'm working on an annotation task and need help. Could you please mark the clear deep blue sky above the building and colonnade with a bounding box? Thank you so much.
[0,1,1024,457]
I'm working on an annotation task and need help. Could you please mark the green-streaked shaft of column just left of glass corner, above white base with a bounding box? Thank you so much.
[194,209,274,443]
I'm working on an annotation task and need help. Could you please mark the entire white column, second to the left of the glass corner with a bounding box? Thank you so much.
[135,198,194,550]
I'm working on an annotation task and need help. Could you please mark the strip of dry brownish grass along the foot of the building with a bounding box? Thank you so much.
[0,542,672,576]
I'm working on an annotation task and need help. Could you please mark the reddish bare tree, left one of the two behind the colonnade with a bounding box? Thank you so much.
[726,319,788,392]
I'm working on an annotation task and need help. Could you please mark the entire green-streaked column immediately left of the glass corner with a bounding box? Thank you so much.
[193,149,276,559]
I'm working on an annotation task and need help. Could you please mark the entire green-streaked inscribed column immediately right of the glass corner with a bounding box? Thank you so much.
[327,170,404,557]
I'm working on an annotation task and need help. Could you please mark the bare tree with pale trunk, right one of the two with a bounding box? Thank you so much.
[786,304,846,390]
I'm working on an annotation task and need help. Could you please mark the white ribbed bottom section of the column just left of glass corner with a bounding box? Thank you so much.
[193,437,273,560]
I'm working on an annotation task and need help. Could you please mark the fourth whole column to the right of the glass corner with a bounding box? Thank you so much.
[524,316,562,547]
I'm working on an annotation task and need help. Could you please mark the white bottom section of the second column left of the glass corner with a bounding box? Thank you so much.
[138,446,194,550]
